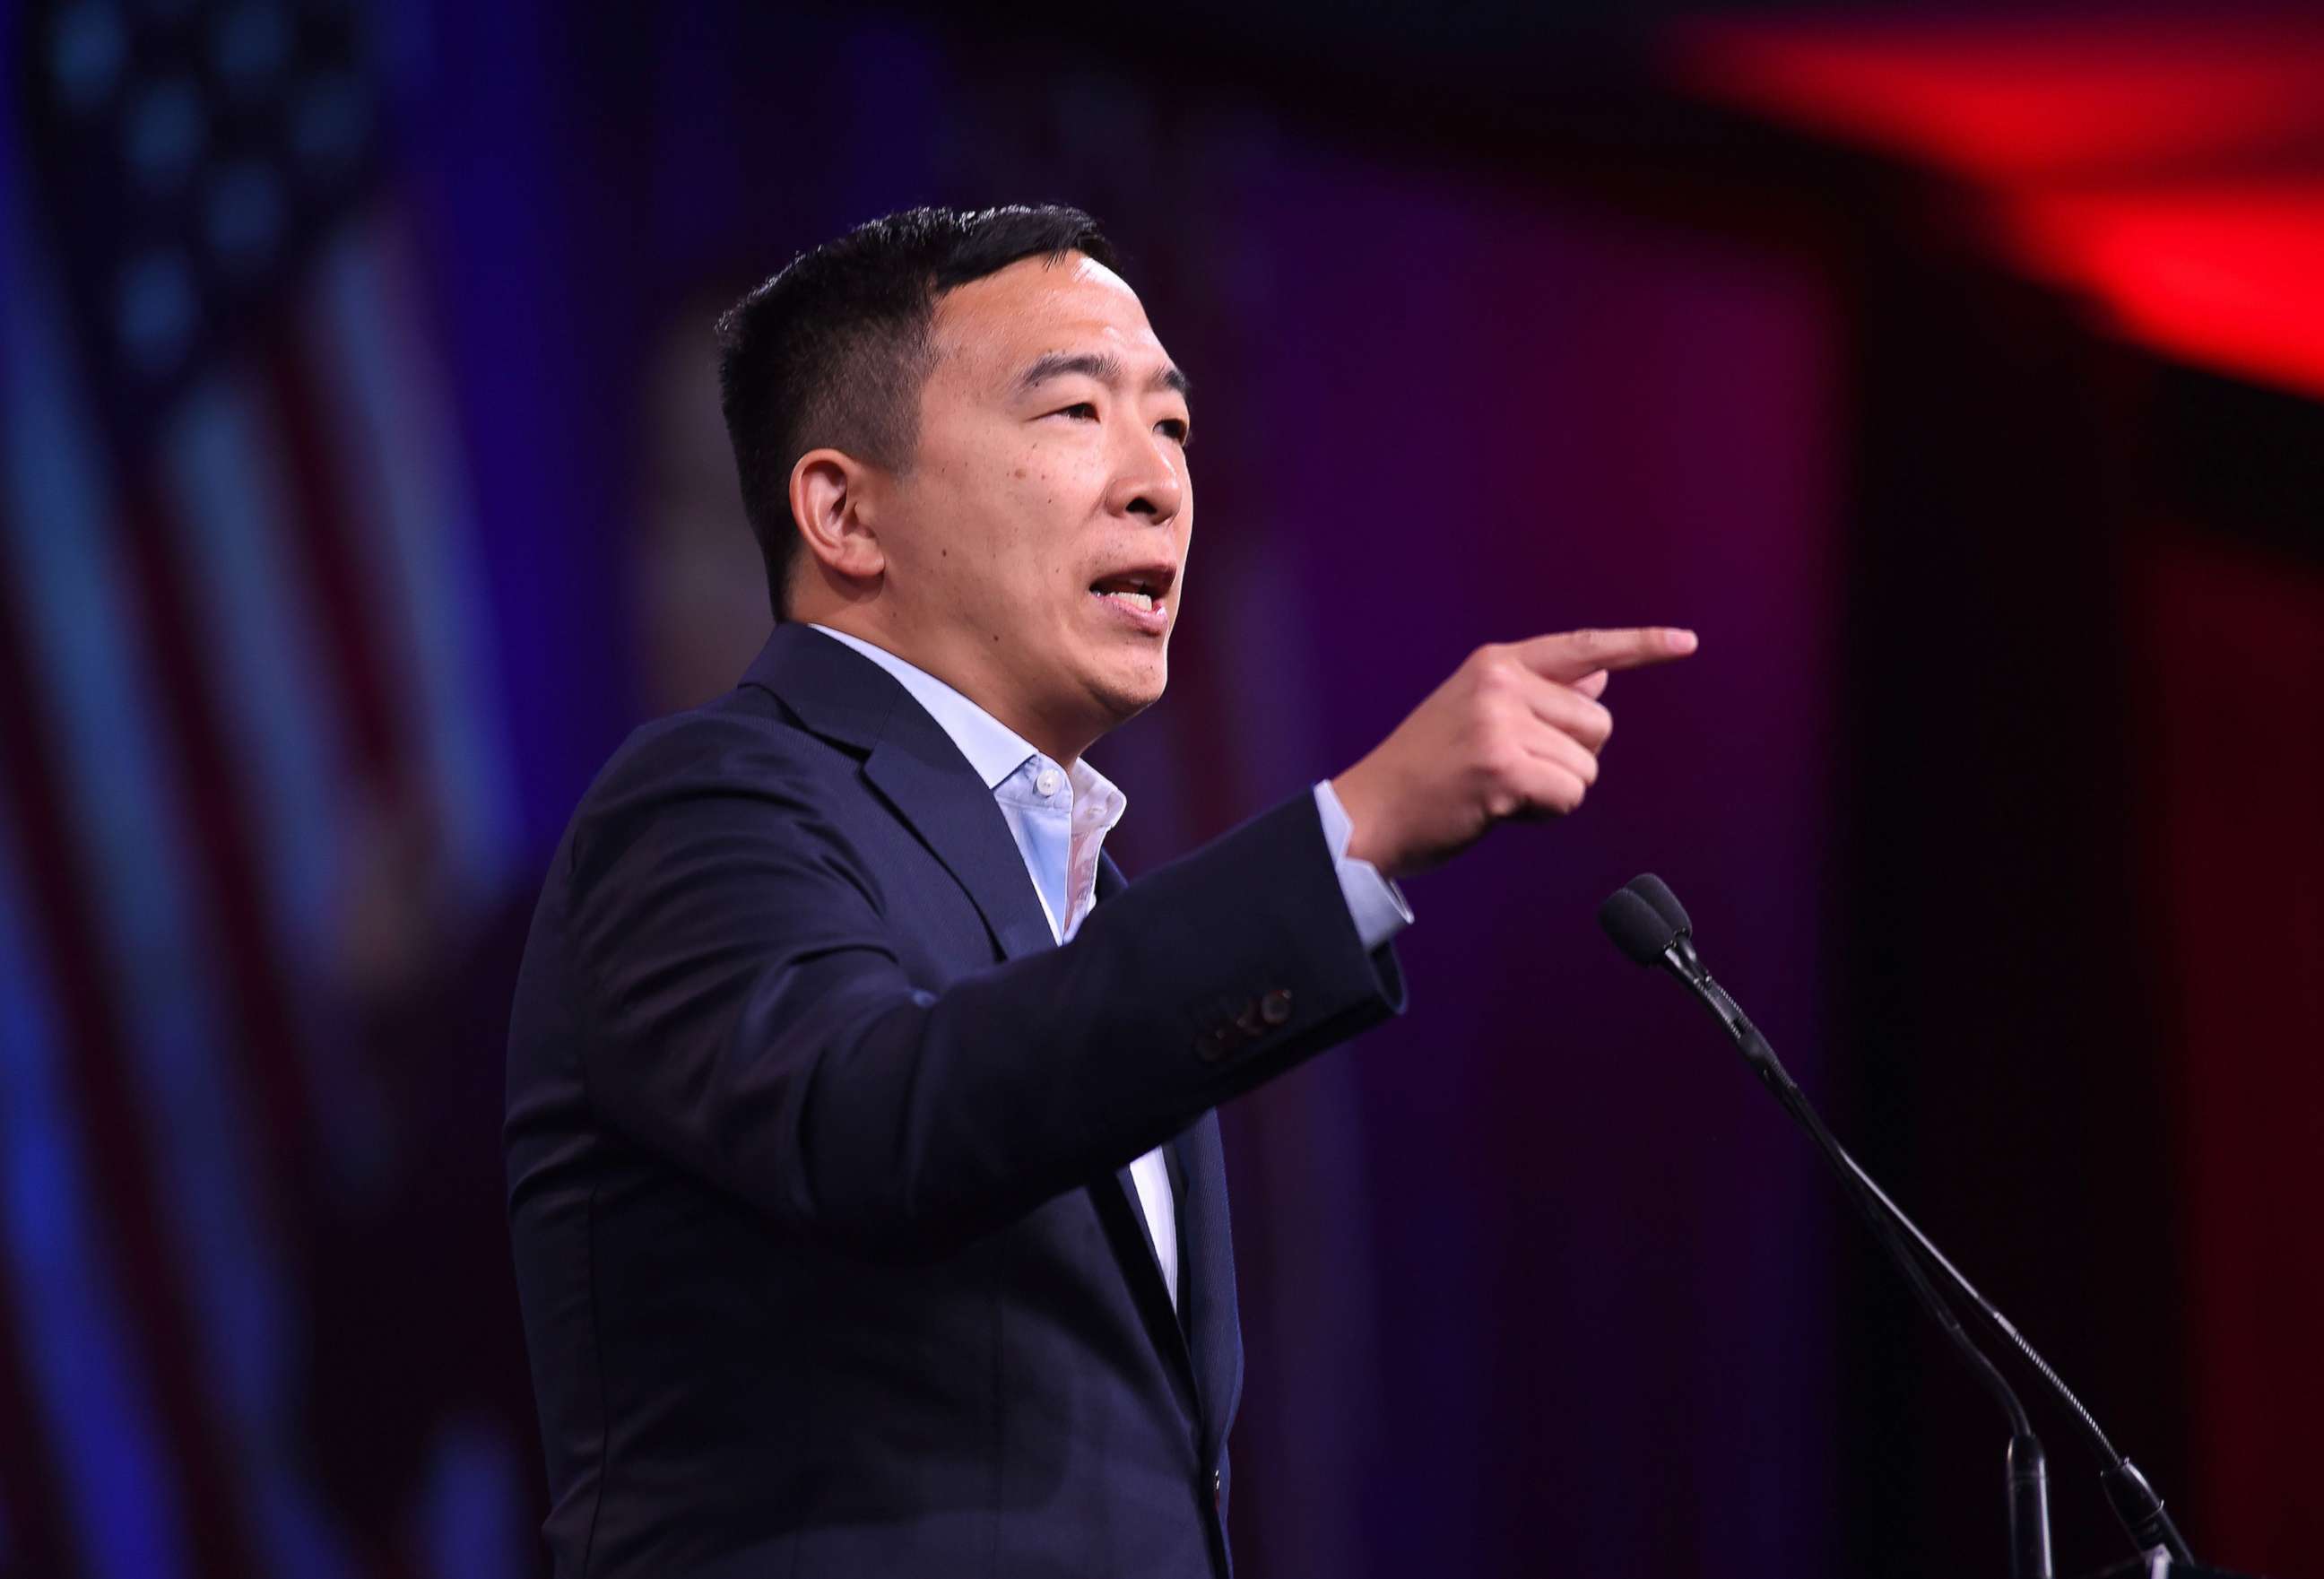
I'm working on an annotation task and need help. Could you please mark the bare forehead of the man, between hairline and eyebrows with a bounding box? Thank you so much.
[934,251,1169,379]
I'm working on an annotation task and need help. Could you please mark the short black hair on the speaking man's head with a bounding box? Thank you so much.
[718,204,1118,620]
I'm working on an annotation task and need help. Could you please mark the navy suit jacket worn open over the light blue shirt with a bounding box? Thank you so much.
[507,626,1404,1579]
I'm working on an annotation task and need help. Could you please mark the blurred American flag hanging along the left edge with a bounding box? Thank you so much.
[0,0,523,1579]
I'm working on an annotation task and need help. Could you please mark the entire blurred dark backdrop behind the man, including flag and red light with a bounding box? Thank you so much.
[0,0,2324,1579]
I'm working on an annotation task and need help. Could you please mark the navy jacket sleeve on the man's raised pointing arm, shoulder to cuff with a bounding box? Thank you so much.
[565,725,1404,1256]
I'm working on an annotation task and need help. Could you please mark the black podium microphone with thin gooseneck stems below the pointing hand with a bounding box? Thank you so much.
[1599,872,2194,1572]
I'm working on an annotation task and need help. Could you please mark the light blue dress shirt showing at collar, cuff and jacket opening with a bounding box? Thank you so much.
[813,626,1413,1302]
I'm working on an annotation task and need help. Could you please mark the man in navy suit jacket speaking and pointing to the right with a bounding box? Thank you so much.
[507,207,1695,1579]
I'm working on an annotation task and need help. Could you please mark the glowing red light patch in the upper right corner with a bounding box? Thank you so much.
[1673,19,2324,395]
